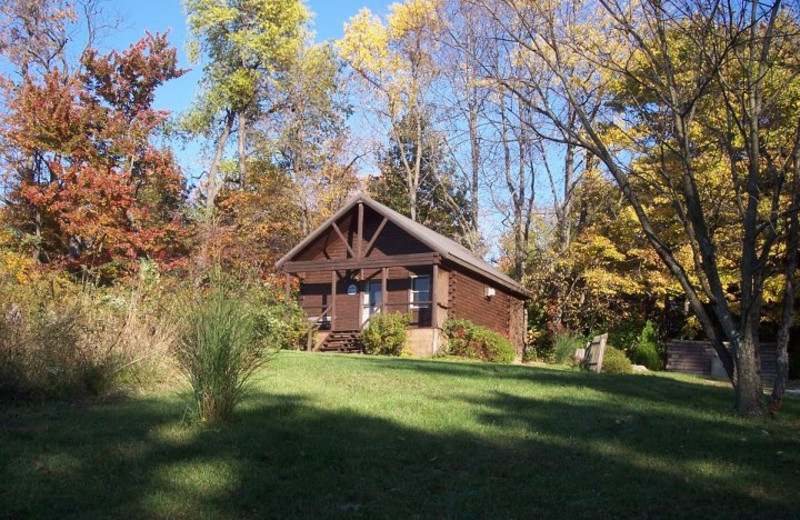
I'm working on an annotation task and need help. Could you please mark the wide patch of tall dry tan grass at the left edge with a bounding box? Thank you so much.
[0,280,174,402]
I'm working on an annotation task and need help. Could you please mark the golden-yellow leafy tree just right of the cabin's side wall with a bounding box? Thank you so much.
[525,171,680,338]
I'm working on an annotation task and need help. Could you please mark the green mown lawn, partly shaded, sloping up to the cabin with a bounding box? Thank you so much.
[0,352,800,519]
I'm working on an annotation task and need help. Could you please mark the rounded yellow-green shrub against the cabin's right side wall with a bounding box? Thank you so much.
[442,319,516,363]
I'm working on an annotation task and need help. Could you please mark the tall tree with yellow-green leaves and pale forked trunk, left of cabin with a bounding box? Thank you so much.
[184,0,309,219]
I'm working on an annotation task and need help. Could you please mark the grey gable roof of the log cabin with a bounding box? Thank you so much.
[275,194,530,297]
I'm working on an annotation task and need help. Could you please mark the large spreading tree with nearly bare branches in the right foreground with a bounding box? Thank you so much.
[481,0,800,414]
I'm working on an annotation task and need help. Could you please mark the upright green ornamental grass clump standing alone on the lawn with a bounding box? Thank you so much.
[176,289,269,422]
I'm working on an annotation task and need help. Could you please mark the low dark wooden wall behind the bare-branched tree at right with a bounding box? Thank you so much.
[666,340,778,381]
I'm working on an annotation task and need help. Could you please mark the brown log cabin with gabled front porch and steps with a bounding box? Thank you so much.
[277,195,529,356]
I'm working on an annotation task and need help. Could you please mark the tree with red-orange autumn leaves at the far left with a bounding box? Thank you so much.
[3,34,184,269]
